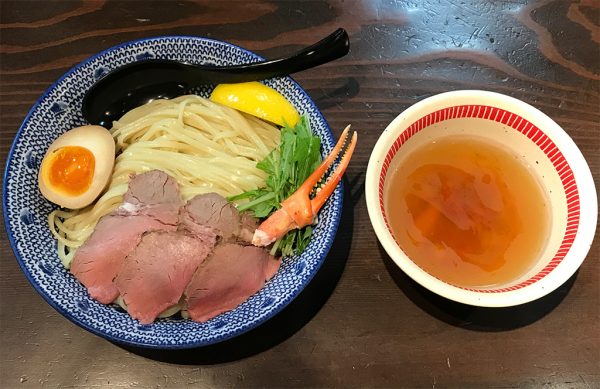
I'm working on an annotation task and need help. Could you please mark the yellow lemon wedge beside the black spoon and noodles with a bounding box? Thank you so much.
[210,81,300,127]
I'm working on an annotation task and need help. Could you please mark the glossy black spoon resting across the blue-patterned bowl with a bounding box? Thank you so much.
[82,28,349,128]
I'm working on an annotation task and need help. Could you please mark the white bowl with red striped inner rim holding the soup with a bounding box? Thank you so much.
[365,90,598,307]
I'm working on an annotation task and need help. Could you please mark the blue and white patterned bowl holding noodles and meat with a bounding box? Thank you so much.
[2,36,343,349]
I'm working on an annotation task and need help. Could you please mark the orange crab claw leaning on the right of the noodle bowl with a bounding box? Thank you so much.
[252,126,357,246]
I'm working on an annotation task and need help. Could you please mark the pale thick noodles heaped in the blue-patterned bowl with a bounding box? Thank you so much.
[48,95,279,268]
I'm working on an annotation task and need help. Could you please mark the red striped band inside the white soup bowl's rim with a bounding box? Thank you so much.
[379,105,580,293]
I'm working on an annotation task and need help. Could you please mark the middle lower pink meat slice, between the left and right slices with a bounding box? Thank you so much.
[115,231,212,324]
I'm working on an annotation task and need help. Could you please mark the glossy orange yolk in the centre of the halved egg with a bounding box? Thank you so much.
[48,146,95,196]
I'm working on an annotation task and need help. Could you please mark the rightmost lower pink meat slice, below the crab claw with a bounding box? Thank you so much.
[185,243,281,322]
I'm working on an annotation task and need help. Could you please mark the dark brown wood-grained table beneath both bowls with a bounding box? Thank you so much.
[0,0,600,388]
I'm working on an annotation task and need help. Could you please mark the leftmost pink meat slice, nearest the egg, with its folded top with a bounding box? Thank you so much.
[71,171,181,304]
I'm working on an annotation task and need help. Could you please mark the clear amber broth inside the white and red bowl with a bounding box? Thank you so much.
[385,136,550,288]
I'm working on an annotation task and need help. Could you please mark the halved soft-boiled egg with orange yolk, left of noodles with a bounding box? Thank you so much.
[38,126,115,209]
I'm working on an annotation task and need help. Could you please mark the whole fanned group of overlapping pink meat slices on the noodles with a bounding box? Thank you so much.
[71,171,280,324]
